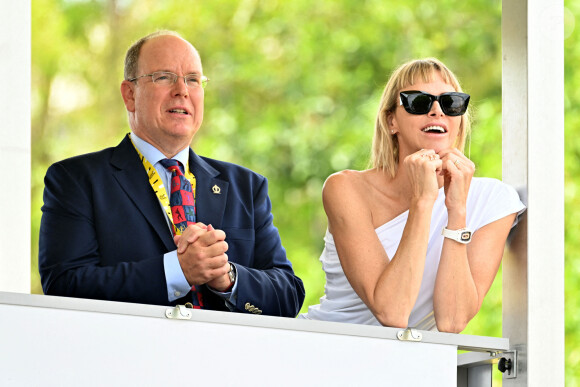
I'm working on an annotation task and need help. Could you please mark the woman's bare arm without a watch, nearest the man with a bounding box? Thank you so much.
[323,155,440,327]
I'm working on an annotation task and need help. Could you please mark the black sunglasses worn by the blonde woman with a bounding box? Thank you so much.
[399,90,469,116]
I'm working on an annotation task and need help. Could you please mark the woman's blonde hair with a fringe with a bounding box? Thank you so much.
[371,58,471,177]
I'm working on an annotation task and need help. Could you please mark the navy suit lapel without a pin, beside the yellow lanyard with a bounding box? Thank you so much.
[111,135,175,251]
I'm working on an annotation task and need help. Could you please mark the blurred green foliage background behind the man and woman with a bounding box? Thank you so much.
[32,0,580,386]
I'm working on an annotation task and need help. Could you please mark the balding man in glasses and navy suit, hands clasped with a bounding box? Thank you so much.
[39,31,304,317]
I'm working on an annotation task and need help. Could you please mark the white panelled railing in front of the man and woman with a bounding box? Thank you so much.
[0,292,509,387]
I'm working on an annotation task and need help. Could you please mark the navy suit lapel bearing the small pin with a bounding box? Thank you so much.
[189,149,229,228]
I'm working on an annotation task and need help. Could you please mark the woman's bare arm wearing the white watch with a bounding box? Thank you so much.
[433,149,515,332]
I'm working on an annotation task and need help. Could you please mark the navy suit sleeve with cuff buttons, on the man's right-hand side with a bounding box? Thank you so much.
[226,178,304,317]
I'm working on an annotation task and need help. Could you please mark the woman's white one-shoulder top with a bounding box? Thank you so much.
[298,178,525,330]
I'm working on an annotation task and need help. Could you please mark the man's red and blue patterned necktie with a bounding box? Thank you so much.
[160,159,203,309]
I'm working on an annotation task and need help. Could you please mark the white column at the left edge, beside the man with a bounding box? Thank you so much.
[0,0,31,293]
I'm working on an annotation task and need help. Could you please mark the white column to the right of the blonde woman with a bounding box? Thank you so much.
[502,0,565,386]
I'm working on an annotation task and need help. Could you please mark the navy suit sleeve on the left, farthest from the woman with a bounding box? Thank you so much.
[39,164,169,305]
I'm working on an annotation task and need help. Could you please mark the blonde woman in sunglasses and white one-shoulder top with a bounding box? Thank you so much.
[301,58,525,332]
